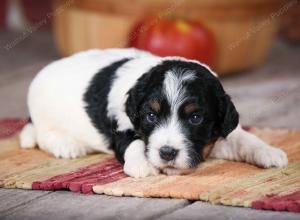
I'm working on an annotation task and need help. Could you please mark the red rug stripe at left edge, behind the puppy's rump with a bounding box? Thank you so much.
[0,119,27,139]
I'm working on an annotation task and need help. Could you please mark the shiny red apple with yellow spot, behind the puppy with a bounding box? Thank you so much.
[129,18,215,66]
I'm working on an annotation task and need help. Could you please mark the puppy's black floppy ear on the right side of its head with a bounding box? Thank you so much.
[218,93,239,138]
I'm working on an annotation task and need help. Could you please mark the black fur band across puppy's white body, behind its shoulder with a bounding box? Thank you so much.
[84,59,137,163]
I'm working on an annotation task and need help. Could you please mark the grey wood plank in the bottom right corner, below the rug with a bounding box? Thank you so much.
[159,202,299,220]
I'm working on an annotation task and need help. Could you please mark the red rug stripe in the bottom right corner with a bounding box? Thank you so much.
[251,191,300,212]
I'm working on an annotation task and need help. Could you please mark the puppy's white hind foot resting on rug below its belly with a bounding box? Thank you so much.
[37,131,91,158]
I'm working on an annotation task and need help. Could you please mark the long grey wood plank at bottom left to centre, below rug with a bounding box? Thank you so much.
[0,191,189,220]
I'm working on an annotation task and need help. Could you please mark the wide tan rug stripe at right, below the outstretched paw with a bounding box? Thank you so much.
[200,162,300,207]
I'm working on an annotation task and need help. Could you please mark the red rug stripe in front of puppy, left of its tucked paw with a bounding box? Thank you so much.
[32,159,127,194]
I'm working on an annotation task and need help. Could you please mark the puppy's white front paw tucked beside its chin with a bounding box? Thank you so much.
[124,160,159,178]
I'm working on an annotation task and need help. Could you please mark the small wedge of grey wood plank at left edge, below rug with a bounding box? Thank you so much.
[0,189,51,214]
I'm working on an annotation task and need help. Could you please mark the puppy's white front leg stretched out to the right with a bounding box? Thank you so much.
[210,125,288,168]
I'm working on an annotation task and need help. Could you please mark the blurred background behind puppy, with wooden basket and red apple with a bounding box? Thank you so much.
[0,0,300,128]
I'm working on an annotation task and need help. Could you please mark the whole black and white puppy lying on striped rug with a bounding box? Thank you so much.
[20,49,288,177]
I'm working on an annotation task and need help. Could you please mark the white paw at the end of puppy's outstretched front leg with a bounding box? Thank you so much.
[254,146,288,168]
